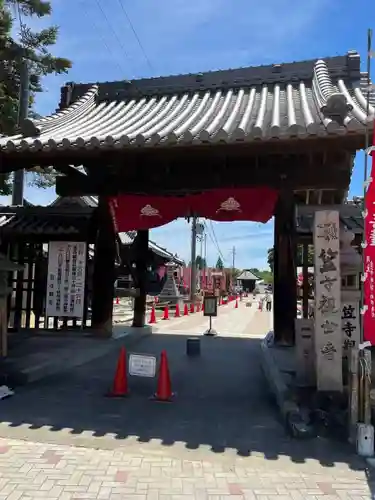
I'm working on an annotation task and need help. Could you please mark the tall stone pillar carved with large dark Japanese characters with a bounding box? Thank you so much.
[314,210,343,392]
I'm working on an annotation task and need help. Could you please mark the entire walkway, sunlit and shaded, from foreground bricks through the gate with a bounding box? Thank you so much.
[0,303,371,500]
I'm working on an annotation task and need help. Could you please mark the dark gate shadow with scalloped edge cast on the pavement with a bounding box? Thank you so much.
[0,334,363,469]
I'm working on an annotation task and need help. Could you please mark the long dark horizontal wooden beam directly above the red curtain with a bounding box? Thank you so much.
[56,162,350,196]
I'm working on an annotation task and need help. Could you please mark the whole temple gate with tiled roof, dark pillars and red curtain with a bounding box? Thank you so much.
[0,51,375,342]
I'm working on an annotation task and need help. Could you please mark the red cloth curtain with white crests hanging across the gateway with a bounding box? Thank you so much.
[110,187,278,232]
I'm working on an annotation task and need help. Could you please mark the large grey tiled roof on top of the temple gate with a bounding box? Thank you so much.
[0,51,375,152]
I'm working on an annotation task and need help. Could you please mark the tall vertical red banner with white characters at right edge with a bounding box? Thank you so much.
[363,127,375,345]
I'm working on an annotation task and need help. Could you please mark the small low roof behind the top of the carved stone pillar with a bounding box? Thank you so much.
[297,204,364,236]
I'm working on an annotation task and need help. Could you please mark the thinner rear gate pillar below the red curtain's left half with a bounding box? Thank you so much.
[133,229,149,328]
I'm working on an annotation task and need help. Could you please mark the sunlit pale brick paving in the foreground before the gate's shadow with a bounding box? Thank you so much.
[0,439,371,500]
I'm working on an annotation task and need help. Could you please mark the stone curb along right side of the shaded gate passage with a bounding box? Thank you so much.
[261,331,315,439]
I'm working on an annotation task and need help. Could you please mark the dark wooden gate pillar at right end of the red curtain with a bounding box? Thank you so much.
[273,191,297,345]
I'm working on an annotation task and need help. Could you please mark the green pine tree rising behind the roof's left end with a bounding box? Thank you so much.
[0,0,71,194]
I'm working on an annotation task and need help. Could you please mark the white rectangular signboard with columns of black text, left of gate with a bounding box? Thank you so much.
[46,241,86,318]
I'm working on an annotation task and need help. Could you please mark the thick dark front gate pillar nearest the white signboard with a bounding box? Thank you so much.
[92,196,116,337]
